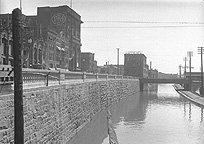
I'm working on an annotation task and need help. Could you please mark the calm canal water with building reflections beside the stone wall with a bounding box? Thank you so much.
[69,84,204,144]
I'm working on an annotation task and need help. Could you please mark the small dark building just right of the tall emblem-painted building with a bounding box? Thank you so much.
[81,52,98,73]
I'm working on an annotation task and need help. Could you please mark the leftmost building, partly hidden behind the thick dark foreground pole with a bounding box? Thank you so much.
[0,14,32,67]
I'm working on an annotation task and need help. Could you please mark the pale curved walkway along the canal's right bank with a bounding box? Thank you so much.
[174,85,204,106]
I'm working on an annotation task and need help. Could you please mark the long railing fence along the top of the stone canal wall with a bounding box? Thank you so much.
[0,66,135,86]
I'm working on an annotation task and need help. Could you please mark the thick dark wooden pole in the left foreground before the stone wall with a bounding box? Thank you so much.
[12,8,24,144]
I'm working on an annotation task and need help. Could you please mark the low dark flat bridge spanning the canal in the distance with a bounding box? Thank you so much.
[139,78,191,91]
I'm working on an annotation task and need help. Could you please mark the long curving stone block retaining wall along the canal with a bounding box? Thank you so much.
[0,80,139,144]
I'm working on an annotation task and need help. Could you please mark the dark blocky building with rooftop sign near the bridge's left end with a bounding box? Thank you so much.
[124,52,149,78]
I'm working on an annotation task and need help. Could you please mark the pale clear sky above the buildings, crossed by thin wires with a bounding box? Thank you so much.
[0,0,204,73]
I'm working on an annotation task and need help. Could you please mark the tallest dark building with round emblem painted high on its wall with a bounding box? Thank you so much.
[37,6,82,71]
